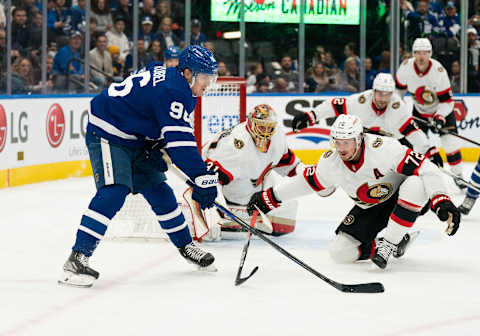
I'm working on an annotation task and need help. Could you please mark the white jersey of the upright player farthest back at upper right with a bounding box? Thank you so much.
[395,57,454,118]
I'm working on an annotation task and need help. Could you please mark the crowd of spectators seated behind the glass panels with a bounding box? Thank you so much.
[0,0,480,94]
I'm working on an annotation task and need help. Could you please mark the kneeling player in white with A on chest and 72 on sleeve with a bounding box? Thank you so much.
[248,114,460,268]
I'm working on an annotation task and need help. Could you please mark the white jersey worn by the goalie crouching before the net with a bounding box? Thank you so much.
[202,121,300,205]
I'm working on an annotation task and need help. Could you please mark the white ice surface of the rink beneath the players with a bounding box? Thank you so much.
[0,164,480,336]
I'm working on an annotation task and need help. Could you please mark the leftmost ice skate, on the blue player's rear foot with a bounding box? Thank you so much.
[58,251,100,287]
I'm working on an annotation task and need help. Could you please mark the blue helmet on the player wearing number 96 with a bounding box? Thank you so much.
[178,45,218,76]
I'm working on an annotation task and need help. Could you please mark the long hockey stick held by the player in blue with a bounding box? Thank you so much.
[163,156,385,293]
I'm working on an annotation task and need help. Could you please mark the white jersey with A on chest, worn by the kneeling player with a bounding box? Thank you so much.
[274,134,446,209]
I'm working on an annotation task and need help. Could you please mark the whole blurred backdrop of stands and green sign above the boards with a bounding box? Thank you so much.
[0,0,480,95]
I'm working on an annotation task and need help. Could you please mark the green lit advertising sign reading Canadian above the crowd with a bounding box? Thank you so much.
[210,0,360,25]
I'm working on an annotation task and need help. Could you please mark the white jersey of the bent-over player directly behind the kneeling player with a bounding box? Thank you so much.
[314,90,432,154]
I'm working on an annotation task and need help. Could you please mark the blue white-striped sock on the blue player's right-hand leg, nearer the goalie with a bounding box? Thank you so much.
[142,183,192,247]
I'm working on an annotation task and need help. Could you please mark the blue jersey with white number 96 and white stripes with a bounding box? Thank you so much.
[87,62,207,180]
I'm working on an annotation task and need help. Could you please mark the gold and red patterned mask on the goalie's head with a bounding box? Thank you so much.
[247,104,277,153]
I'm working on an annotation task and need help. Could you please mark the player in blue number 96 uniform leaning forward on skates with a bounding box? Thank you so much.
[59,46,218,287]
